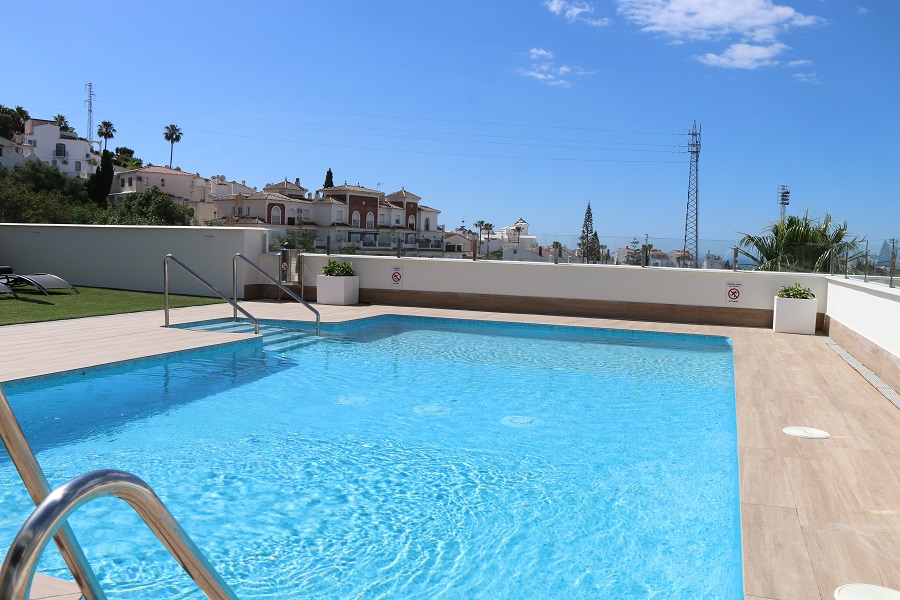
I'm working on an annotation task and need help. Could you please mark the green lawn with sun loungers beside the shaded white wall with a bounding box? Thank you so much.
[0,286,222,325]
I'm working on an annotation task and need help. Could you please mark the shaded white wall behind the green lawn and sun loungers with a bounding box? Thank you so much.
[0,223,277,296]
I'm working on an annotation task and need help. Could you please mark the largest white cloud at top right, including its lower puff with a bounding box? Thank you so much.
[616,0,823,70]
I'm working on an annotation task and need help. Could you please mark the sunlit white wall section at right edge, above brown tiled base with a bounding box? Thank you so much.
[828,277,900,356]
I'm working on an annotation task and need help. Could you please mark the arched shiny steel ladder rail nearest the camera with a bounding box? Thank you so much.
[0,469,237,600]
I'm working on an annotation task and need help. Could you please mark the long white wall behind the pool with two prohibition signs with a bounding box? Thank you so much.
[303,254,828,313]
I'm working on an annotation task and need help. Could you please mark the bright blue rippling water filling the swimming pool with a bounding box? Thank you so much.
[0,318,743,600]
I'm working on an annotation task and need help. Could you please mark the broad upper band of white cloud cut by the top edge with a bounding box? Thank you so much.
[617,0,820,42]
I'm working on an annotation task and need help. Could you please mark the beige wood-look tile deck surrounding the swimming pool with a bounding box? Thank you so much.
[0,302,900,600]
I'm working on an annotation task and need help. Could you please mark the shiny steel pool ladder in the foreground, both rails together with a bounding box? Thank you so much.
[0,389,237,600]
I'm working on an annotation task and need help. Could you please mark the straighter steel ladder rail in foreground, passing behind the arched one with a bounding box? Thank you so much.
[0,389,106,600]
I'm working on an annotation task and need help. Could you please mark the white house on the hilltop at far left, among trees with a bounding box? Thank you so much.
[15,119,100,179]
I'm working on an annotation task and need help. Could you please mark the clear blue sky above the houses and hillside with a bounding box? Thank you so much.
[0,0,900,246]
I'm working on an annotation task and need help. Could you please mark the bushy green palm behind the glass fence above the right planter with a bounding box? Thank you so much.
[738,212,859,273]
